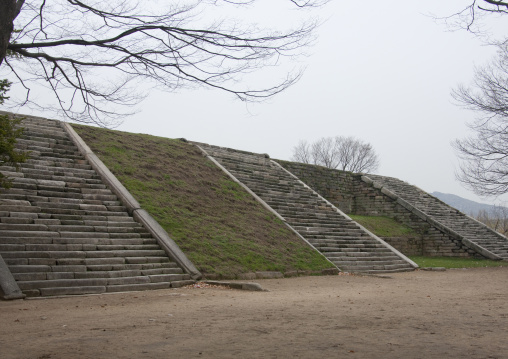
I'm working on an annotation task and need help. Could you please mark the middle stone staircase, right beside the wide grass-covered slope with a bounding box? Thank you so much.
[197,143,414,273]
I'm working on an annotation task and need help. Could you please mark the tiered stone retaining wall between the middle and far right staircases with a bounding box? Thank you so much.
[277,160,478,257]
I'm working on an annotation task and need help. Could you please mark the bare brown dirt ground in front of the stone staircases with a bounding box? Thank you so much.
[0,267,508,359]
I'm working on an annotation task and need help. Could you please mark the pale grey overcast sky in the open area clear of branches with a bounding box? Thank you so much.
[3,0,508,203]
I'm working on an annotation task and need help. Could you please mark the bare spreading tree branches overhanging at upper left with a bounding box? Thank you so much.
[0,0,326,125]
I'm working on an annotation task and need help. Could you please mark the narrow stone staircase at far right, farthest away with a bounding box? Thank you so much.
[367,174,508,260]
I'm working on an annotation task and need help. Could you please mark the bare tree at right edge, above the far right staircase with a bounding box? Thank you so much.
[452,45,508,196]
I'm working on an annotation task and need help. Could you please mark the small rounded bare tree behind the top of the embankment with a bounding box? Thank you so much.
[291,136,379,172]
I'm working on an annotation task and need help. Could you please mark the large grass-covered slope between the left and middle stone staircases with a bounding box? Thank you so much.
[74,125,332,278]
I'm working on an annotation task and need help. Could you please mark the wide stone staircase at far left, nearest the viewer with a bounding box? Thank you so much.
[0,117,194,296]
